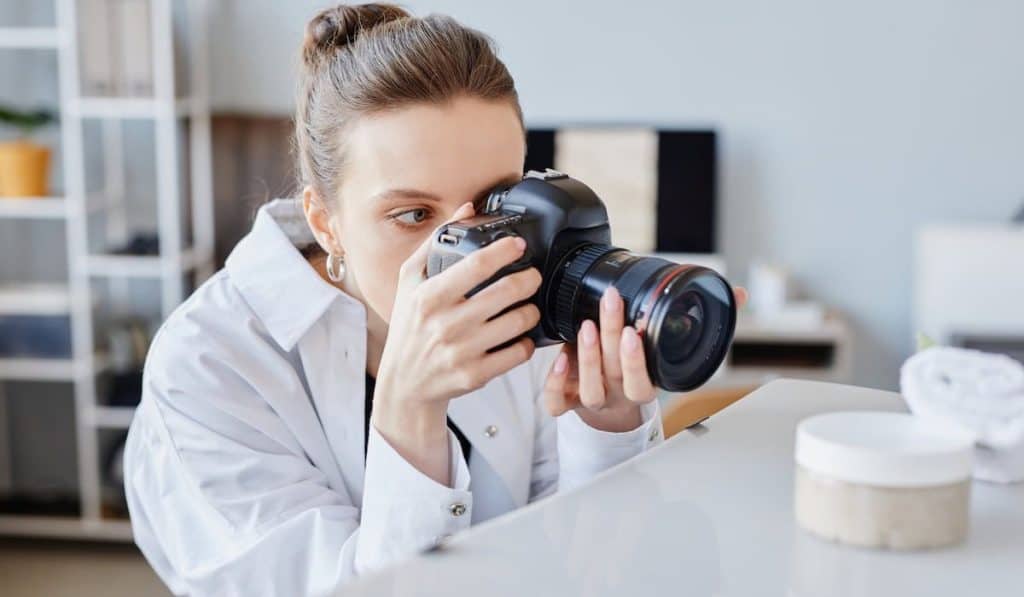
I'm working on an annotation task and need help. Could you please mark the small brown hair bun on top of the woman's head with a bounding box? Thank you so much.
[302,3,410,66]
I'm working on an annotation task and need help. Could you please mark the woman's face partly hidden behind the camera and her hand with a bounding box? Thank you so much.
[313,97,526,322]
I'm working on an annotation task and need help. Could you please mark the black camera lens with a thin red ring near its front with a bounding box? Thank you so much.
[544,244,736,391]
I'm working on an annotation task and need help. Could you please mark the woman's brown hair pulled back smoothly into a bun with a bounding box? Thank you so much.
[294,4,522,207]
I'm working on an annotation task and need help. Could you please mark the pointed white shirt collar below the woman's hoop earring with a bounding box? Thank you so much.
[224,198,366,350]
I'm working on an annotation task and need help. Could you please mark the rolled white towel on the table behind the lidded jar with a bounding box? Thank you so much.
[900,346,1024,483]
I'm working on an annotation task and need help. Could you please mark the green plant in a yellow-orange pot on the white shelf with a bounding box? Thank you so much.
[0,105,53,197]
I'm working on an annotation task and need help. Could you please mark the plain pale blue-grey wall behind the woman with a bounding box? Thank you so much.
[214,0,1024,388]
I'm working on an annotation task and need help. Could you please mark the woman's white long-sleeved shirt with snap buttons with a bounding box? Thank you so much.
[125,199,662,596]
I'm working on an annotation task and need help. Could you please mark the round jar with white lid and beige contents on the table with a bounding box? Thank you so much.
[794,411,974,549]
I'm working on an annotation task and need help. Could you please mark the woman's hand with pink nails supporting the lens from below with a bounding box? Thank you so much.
[544,287,746,432]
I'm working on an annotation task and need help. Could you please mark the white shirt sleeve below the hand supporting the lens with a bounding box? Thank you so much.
[529,344,664,501]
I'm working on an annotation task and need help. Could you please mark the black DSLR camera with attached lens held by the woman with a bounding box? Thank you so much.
[427,169,736,391]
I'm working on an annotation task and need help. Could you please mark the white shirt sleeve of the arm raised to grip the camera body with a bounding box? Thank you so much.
[125,317,472,596]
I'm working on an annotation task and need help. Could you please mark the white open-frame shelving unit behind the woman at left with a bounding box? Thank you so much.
[0,0,214,541]
